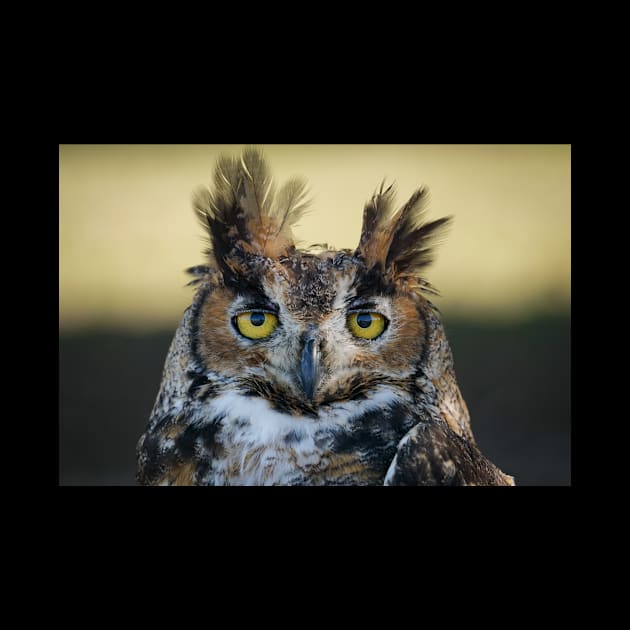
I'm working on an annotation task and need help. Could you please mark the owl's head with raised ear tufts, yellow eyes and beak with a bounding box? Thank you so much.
[189,149,449,416]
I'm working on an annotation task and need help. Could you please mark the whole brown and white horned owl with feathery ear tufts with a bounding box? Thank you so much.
[136,148,514,485]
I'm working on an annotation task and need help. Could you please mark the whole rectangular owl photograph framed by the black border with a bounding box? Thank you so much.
[58,143,571,487]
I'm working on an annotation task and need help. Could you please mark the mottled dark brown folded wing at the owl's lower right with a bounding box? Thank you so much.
[385,422,514,486]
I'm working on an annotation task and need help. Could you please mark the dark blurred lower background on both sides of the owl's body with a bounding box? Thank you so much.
[59,316,571,485]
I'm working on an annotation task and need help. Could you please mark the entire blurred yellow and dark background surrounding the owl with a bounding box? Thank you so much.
[59,145,571,485]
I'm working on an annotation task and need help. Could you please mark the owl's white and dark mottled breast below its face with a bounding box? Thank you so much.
[190,394,414,485]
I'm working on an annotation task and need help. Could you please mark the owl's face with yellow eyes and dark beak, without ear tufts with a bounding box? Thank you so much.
[196,251,428,416]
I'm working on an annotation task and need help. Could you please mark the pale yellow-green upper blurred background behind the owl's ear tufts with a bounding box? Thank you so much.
[59,145,571,330]
